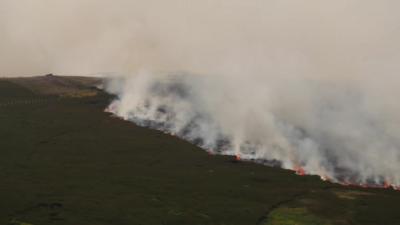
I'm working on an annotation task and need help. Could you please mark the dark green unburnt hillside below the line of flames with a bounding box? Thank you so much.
[0,80,400,225]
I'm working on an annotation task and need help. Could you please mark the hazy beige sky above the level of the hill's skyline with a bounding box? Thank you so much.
[0,0,400,77]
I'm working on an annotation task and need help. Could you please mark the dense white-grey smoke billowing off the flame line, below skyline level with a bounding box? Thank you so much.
[109,73,400,185]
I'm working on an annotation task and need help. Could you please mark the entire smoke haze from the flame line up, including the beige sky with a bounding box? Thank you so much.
[0,0,400,185]
